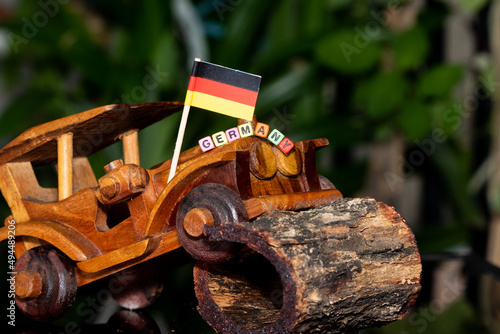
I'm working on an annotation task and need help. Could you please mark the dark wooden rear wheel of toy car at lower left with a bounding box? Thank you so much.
[14,246,77,321]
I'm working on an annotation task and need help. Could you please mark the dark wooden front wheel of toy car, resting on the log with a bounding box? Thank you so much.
[176,183,248,262]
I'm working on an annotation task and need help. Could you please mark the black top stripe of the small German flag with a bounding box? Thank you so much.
[191,61,261,92]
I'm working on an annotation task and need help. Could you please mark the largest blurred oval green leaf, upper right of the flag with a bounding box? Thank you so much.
[314,29,382,74]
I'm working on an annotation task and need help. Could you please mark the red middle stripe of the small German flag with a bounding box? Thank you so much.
[188,76,258,107]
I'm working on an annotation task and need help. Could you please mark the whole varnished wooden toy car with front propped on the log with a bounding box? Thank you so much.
[0,102,342,320]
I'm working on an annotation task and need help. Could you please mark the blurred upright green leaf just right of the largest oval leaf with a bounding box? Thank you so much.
[394,27,429,71]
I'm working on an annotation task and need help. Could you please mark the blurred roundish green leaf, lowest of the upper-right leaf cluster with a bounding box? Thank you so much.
[399,101,432,140]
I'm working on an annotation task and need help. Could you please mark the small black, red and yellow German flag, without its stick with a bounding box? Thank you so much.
[184,59,261,120]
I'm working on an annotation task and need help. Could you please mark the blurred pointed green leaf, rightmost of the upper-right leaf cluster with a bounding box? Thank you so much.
[417,65,462,97]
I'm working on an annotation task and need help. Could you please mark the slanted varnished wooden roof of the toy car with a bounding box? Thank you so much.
[0,102,182,165]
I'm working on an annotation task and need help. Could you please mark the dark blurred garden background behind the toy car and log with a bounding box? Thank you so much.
[0,0,500,333]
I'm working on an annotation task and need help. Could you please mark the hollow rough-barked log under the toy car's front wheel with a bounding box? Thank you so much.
[194,198,421,334]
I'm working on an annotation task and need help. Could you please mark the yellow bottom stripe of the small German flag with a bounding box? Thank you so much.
[186,91,255,120]
